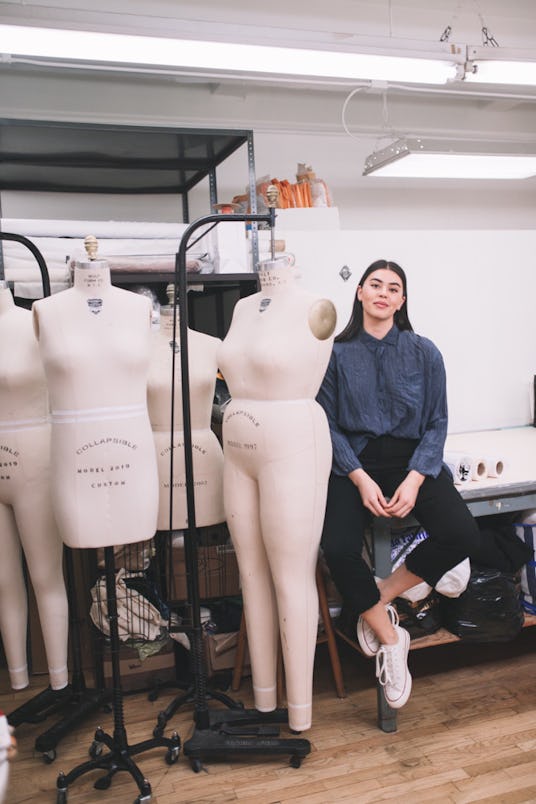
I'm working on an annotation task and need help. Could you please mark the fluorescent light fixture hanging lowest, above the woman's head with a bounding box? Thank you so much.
[363,138,536,179]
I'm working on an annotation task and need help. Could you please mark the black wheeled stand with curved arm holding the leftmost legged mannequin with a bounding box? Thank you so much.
[0,232,109,763]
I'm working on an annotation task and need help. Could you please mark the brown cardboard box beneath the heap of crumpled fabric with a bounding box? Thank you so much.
[103,639,176,692]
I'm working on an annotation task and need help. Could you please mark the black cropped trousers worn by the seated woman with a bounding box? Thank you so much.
[322,436,485,617]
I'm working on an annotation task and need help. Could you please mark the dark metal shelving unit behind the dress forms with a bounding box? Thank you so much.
[0,118,258,324]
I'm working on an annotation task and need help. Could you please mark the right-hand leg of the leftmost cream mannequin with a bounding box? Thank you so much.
[15,484,69,690]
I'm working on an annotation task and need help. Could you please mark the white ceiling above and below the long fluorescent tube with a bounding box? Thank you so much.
[0,0,536,183]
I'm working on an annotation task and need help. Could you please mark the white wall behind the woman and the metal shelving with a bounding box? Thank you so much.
[1,66,536,432]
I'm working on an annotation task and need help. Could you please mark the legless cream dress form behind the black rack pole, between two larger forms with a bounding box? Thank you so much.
[147,286,225,530]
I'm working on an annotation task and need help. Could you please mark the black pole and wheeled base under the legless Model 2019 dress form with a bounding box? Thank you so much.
[56,547,180,804]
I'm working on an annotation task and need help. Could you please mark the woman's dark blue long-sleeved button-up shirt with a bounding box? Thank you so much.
[317,325,448,477]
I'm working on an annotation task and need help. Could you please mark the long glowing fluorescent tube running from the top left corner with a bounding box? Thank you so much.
[0,25,463,84]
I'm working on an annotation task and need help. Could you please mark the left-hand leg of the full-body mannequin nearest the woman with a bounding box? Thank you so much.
[224,462,279,712]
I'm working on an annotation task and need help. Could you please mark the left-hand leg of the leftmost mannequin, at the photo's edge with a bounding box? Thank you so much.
[0,503,29,690]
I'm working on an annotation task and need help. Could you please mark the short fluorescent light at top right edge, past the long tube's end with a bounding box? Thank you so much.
[465,45,536,86]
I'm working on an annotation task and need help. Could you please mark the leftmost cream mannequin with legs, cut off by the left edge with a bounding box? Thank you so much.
[0,282,69,689]
